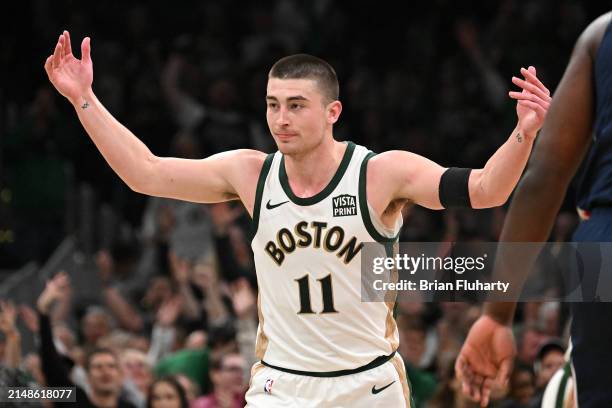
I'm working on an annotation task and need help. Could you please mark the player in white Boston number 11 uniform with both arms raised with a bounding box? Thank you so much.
[45,32,550,407]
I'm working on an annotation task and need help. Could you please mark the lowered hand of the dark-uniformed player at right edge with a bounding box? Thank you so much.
[455,315,516,407]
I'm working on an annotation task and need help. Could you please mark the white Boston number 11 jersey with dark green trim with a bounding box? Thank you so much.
[251,142,401,372]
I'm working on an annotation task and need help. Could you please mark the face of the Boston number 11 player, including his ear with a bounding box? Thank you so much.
[266,78,341,155]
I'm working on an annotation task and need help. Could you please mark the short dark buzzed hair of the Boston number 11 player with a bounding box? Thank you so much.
[268,54,340,102]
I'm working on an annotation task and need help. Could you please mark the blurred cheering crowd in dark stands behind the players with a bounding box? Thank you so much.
[0,0,604,408]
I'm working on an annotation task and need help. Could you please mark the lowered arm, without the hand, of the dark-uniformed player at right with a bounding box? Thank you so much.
[485,13,612,324]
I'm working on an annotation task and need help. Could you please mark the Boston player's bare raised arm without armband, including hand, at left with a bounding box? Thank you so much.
[45,31,265,209]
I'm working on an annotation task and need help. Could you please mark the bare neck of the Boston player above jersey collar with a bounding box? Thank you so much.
[285,138,348,197]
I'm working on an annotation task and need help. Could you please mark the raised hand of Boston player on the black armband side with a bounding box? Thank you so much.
[509,66,551,139]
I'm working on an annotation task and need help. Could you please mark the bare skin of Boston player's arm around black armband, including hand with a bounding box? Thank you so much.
[372,67,550,209]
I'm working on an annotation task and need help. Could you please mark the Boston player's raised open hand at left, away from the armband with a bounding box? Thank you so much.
[45,31,93,102]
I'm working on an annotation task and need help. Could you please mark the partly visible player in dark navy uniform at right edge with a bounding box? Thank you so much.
[456,13,612,408]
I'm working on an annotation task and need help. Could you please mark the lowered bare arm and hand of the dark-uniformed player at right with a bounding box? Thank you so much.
[455,13,612,406]
